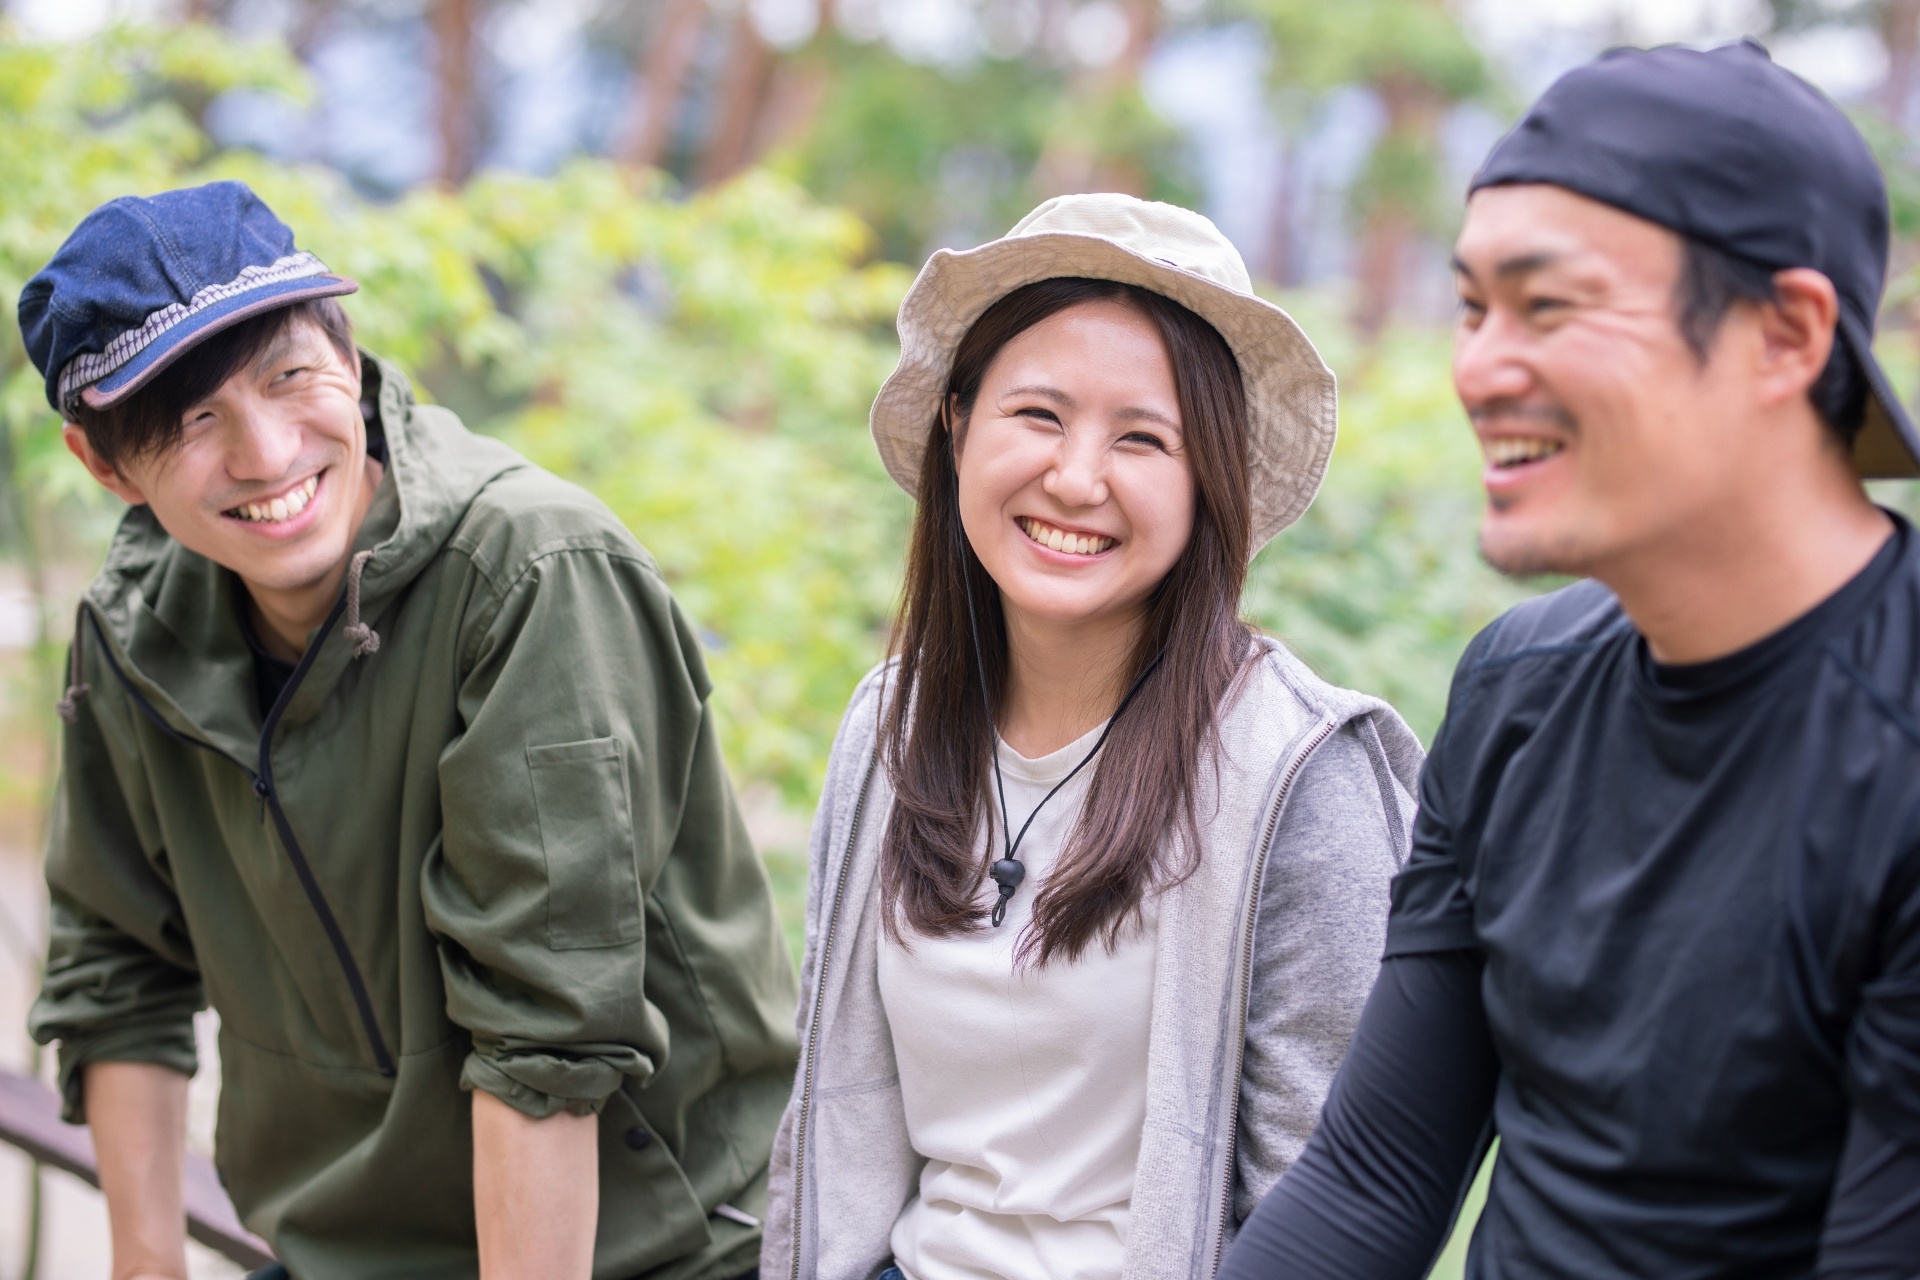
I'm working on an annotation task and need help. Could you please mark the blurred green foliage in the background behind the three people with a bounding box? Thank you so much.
[0,20,1920,1280]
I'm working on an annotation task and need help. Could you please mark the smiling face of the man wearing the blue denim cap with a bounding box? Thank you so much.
[67,317,374,612]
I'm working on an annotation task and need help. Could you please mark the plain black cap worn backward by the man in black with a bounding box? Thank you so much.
[1469,38,1920,478]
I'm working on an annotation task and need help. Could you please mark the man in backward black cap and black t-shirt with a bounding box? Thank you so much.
[1223,44,1920,1280]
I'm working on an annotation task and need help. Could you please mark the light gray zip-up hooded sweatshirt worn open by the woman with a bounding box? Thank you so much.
[760,639,1421,1280]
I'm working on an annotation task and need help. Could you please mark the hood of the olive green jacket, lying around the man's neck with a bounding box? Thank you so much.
[75,351,528,760]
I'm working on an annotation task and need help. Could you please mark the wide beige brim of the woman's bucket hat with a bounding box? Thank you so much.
[870,232,1338,555]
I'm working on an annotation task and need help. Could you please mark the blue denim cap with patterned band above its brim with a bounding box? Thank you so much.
[19,182,359,418]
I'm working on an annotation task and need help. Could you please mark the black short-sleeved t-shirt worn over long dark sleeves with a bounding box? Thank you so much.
[1386,520,1920,1276]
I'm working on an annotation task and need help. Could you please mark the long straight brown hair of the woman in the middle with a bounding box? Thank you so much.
[879,276,1252,965]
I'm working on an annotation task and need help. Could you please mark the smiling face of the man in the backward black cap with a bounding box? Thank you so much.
[1453,186,1751,576]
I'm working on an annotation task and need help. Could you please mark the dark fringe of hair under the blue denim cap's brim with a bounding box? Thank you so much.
[73,297,355,466]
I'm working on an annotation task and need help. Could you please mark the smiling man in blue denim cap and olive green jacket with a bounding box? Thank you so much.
[19,182,795,1280]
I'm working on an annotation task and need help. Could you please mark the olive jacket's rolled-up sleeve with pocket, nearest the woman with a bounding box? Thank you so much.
[422,547,707,1117]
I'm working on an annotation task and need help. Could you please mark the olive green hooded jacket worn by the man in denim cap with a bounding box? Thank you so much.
[33,359,795,1280]
